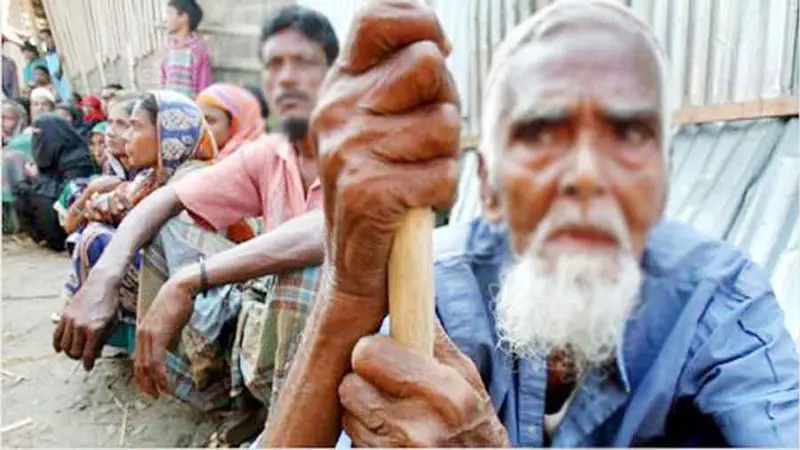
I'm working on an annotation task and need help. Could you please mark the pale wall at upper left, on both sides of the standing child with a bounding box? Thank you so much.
[37,0,294,92]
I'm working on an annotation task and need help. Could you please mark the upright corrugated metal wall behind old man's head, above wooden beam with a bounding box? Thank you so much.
[299,0,800,136]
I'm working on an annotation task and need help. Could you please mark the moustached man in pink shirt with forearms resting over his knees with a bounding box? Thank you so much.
[53,6,339,428]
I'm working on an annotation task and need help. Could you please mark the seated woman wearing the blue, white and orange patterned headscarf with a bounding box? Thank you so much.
[66,91,216,336]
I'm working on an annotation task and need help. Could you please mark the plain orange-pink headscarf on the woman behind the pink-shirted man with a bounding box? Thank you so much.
[196,83,264,158]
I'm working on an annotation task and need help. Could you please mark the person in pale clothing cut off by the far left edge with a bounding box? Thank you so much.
[3,100,32,234]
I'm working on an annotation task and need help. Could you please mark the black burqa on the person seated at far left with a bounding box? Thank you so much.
[14,115,92,250]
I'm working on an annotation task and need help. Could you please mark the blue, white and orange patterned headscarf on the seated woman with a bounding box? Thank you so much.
[126,91,217,206]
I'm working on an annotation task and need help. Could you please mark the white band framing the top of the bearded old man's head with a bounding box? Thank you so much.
[480,0,671,180]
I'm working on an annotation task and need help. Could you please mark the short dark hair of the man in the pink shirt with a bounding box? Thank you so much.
[259,5,339,66]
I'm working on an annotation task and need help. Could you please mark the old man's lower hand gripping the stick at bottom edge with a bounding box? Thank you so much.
[339,327,509,447]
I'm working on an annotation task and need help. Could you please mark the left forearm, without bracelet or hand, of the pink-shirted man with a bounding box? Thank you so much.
[92,186,183,279]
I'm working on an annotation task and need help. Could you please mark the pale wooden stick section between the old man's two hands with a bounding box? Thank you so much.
[389,208,434,355]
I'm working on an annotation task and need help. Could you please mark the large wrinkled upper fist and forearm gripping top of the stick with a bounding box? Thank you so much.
[263,0,460,447]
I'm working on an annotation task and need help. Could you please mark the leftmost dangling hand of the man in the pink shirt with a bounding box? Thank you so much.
[53,269,119,371]
